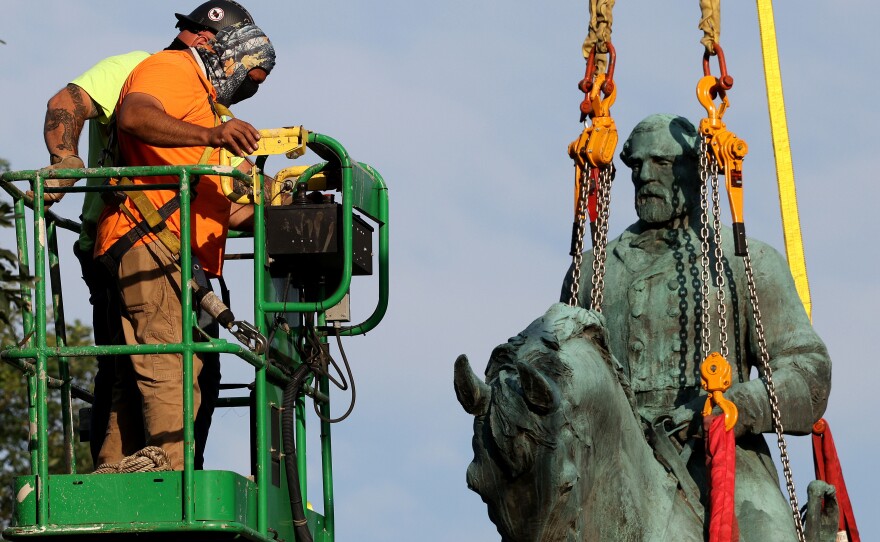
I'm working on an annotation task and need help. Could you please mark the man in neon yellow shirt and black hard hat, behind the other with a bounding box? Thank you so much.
[43,0,262,469]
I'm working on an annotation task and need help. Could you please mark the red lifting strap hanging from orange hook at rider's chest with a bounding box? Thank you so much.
[703,416,739,542]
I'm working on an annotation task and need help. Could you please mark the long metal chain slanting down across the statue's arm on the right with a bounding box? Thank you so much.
[743,252,806,542]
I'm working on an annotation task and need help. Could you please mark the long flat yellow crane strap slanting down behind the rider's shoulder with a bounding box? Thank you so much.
[757,0,813,320]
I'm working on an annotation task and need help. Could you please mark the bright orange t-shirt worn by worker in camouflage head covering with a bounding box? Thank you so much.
[95,51,231,276]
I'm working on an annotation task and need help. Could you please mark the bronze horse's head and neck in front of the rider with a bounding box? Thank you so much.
[455,303,703,542]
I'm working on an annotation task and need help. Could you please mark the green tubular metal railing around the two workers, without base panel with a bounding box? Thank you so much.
[0,133,389,542]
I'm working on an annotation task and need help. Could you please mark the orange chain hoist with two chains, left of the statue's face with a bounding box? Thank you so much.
[568,41,618,312]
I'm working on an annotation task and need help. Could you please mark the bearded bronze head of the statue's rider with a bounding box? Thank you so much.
[620,114,700,225]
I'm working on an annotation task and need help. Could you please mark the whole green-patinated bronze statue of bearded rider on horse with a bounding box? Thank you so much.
[455,115,836,542]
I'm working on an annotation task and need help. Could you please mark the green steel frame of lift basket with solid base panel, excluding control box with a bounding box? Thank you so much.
[0,133,389,542]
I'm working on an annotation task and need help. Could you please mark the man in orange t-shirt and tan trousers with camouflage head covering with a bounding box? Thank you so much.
[95,18,275,470]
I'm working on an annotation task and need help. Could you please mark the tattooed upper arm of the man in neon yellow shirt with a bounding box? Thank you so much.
[43,83,99,167]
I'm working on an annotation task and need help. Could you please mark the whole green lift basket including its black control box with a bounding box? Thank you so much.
[0,131,388,542]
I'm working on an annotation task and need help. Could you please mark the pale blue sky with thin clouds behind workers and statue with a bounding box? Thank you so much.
[0,0,880,542]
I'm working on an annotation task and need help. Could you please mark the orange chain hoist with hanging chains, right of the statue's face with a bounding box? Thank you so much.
[697,42,806,542]
